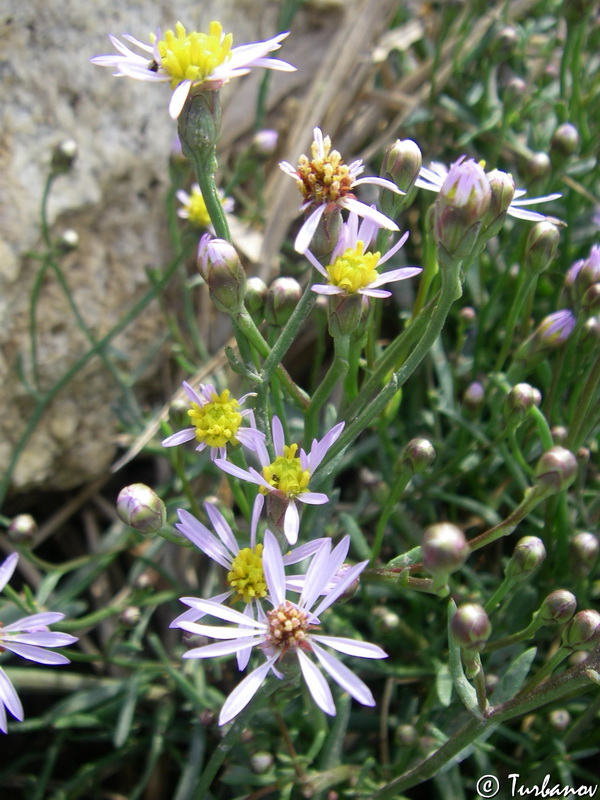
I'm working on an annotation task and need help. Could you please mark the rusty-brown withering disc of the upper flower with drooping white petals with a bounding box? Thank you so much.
[297,136,353,205]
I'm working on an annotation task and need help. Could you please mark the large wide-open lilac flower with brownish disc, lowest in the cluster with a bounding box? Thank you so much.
[180,530,387,725]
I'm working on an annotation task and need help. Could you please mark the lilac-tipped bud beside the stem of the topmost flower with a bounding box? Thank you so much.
[197,233,246,313]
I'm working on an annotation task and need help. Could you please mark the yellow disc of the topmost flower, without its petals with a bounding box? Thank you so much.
[152,22,233,89]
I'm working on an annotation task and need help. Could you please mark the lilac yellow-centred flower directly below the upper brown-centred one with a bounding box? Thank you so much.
[304,211,422,297]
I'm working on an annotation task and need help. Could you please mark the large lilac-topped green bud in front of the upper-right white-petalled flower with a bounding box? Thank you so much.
[433,156,492,258]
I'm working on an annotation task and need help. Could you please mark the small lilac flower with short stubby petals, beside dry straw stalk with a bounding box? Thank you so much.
[162,381,265,461]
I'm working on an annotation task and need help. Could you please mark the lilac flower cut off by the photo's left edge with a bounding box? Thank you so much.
[0,553,77,733]
